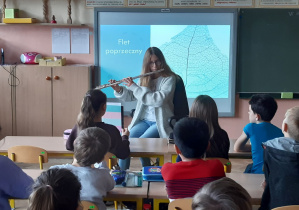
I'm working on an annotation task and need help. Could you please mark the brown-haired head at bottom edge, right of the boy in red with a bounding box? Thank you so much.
[192,177,252,210]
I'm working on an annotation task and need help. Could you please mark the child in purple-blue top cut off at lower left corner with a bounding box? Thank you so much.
[0,155,33,210]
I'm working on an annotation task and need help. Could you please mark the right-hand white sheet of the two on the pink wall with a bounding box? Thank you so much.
[71,28,89,54]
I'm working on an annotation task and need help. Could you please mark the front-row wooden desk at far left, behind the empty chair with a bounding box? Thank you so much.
[0,136,73,157]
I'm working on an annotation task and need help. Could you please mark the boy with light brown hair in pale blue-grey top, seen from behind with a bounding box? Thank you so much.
[51,127,115,209]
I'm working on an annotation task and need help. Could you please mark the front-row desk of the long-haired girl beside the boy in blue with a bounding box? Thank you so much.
[168,139,252,163]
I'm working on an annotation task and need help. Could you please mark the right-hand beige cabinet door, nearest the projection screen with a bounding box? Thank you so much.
[52,65,91,136]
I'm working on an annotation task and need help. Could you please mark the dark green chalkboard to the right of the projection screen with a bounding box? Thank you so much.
[237,9,299,93]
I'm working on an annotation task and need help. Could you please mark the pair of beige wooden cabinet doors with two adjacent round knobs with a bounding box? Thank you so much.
[15,65,91,136]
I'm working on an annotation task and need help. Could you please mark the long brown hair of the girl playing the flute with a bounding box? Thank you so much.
[140,47,174,87]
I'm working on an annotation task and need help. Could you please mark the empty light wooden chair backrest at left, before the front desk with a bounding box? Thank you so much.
[8,146,48,169]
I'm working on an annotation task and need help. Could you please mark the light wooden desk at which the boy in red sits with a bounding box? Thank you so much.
[148,173,264,210]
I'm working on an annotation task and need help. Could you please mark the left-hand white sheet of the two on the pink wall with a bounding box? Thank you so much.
[52,28,71,54]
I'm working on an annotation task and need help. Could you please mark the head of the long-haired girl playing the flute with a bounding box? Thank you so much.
[140,47,173,87]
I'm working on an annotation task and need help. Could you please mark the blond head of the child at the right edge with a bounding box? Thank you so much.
[282,106,299,141]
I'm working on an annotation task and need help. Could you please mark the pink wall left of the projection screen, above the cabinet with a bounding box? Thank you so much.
[0,0,94,64]
